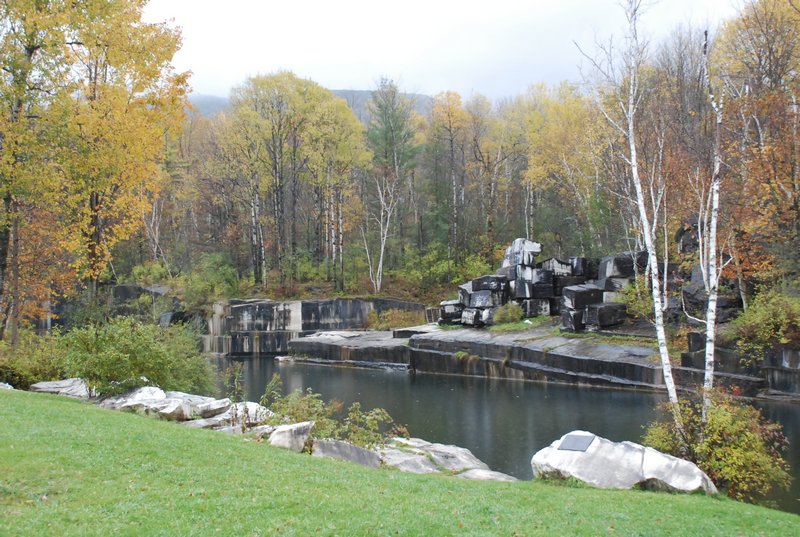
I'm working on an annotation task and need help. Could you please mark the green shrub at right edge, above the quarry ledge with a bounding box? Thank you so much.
[729,291,800,362]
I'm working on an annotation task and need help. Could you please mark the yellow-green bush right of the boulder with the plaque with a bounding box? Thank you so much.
[644,394,791,503]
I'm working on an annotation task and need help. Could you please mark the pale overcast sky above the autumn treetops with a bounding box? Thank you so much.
[145,0,742,99]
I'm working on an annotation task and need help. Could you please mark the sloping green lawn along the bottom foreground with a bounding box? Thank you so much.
[0,390,800,536]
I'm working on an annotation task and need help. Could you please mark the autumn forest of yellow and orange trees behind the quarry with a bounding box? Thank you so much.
[0,0,800,330]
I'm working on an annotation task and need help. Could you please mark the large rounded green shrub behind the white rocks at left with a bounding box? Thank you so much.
[59,317,214,395]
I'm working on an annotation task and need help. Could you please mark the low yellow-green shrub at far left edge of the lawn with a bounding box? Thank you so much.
[0,329,65,390]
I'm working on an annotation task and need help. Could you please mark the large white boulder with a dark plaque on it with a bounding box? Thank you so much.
[531,431,717,494]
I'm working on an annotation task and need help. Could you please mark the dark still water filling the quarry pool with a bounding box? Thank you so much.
[219,358,800,513]
